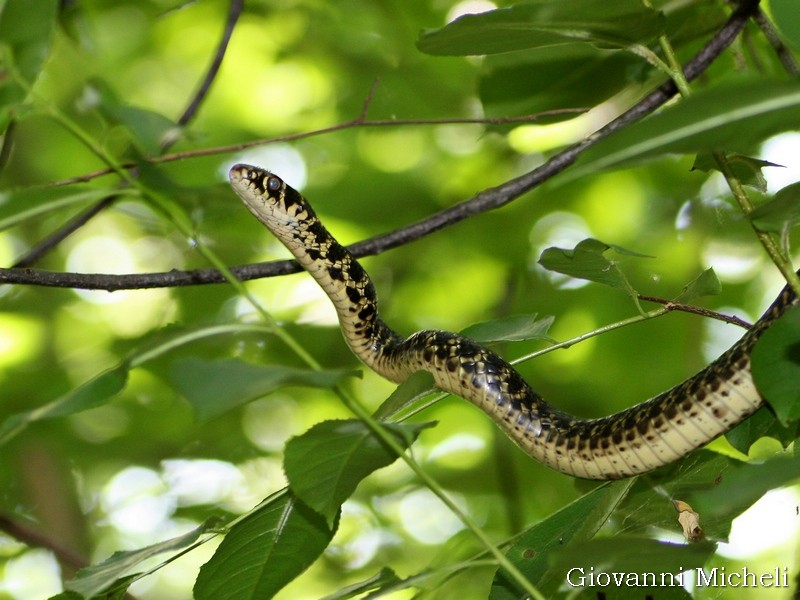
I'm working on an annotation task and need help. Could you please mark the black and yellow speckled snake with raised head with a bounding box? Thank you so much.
[229,164,797,480]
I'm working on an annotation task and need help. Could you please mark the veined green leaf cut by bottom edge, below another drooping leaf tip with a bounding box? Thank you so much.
[194,490,336,600]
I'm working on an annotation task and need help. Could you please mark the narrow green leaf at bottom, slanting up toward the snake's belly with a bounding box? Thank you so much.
[489,478,636,600]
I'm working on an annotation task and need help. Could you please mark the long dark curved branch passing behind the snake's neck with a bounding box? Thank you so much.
[0,0,758,291]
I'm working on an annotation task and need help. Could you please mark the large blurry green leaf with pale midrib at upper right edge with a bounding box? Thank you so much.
[570,80,800,179]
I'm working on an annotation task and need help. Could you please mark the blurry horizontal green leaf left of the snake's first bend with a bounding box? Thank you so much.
[170,358,354,421]
